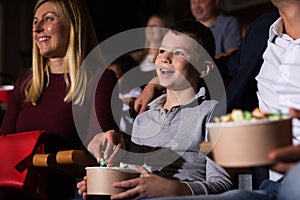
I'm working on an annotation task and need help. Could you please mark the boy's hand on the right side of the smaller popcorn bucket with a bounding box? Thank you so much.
[111,166,192,199]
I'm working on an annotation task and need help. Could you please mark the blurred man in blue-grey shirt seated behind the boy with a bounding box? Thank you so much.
[190,0,241,58]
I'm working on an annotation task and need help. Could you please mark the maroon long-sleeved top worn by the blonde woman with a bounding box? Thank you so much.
[0,70,118,148]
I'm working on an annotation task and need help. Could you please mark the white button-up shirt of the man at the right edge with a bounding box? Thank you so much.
[256,18,300,180]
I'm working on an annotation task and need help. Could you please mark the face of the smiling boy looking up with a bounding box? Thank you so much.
[155,31,200,90]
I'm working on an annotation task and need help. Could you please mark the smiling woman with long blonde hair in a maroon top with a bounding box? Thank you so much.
[0,0,117,200]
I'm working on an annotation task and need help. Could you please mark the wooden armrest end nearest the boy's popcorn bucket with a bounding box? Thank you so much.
[56,150,97,167]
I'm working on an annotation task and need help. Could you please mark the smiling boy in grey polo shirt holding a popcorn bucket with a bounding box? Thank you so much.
[77,20,232,199]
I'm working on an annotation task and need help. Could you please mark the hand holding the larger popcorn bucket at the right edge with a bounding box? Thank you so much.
[269,108,300,173]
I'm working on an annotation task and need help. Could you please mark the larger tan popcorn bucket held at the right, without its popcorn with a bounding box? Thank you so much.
[207,118,292,167]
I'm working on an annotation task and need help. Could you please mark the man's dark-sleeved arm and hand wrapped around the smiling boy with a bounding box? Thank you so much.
[134,10,279,117]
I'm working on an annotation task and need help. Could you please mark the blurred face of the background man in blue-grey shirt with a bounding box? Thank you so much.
[190,0,218,22]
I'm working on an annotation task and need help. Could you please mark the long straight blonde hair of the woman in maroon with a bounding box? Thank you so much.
[25,0,98,105]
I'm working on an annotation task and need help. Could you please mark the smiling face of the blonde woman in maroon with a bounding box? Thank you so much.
[32,2,70,58]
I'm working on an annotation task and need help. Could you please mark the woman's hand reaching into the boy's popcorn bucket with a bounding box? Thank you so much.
[88,130,124,166]
